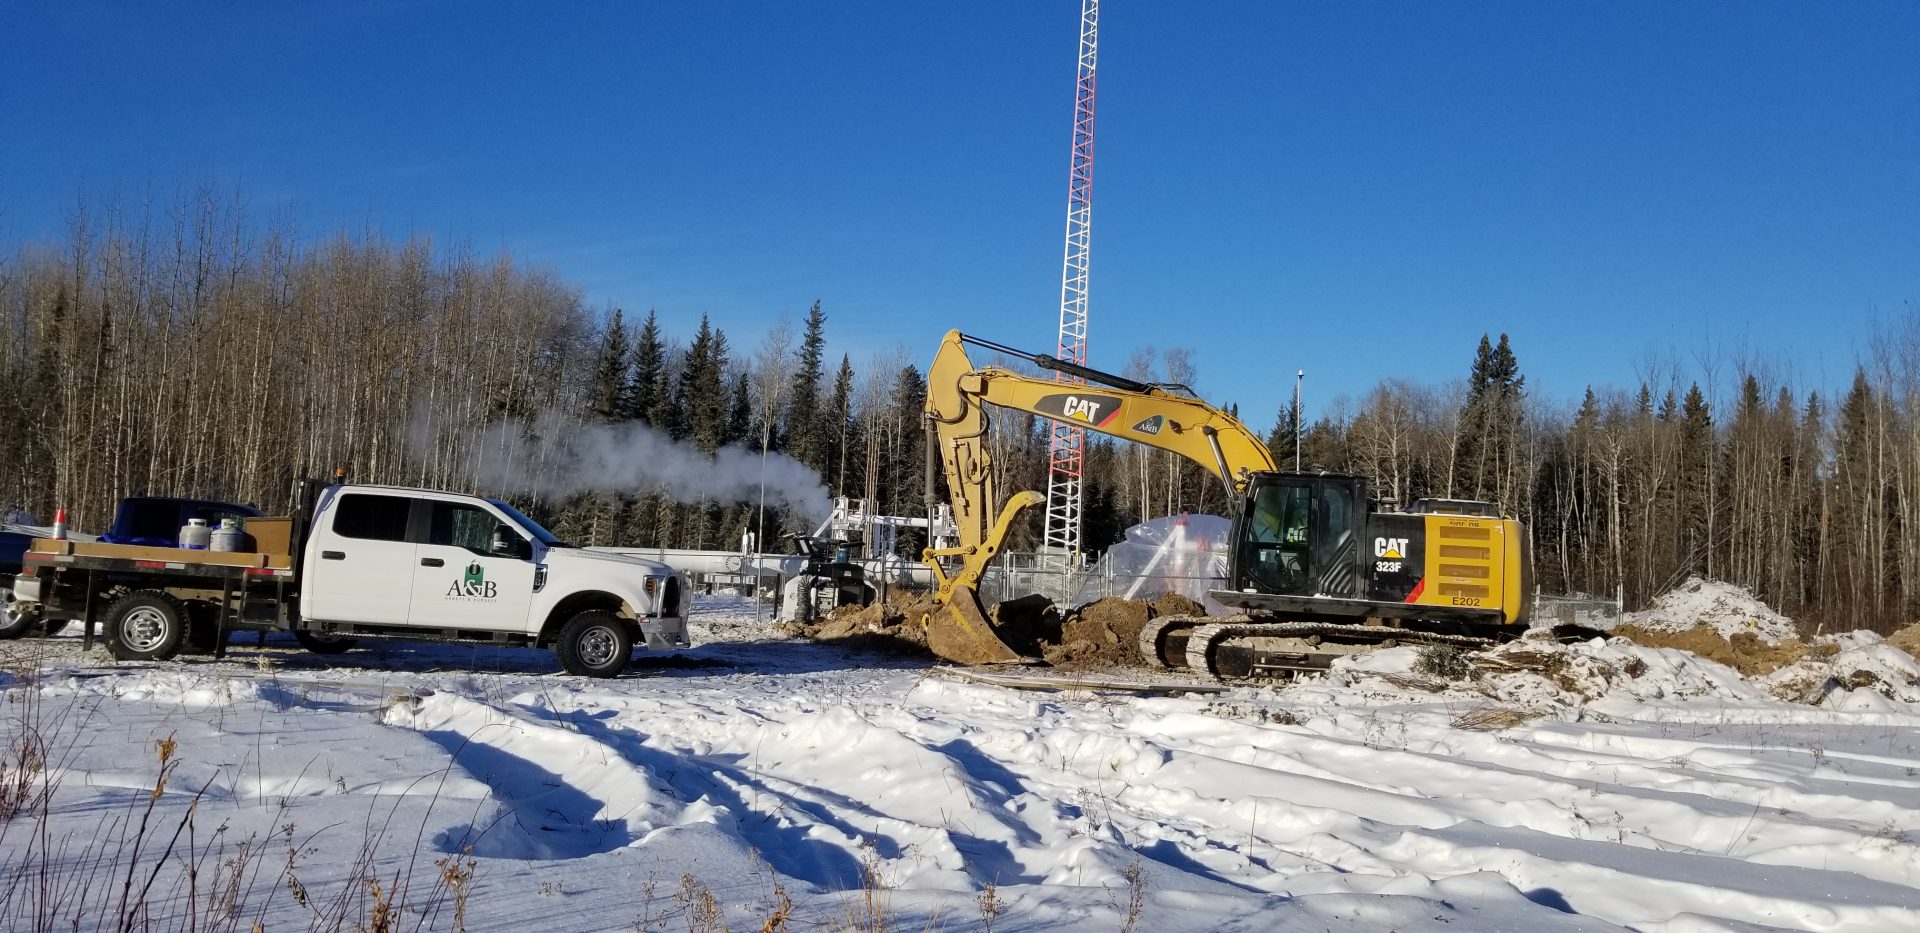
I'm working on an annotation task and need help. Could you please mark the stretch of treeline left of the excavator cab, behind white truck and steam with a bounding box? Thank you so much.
[0,194,1221,555]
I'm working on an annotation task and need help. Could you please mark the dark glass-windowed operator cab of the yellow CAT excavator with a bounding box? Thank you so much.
[1233,472,1367,597]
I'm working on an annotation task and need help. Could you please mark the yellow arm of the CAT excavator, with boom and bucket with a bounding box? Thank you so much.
[924,330,1275,664]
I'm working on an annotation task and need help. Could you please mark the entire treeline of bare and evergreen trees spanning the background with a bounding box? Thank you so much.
[0,196,1920,628]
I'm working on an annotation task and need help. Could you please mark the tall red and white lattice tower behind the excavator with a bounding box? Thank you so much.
[1046,0,1100,562]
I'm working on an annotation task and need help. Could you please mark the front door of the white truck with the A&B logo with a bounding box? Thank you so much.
[411,501,534,632]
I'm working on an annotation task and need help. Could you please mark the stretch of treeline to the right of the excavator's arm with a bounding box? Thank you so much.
[1269,326,1920,630]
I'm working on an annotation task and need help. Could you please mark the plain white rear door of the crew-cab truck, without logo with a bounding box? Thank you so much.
[301,491,415,624]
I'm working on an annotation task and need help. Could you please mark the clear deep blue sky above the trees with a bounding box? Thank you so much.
[0,0,1920,424]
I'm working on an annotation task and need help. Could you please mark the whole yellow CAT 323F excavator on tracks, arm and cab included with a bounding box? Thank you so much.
[924,330,1532,678]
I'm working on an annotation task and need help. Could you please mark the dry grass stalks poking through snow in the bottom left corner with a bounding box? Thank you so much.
[0,656,478,933]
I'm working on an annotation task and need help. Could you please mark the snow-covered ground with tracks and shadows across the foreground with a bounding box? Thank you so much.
[0,599,1920,933]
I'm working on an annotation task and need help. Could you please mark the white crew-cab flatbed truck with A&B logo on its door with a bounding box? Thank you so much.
[13,484,689,678]
